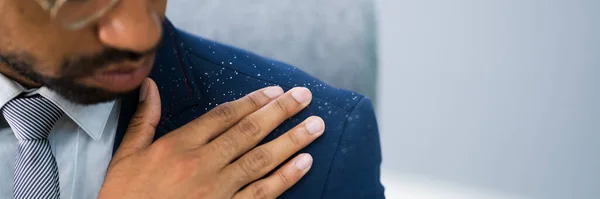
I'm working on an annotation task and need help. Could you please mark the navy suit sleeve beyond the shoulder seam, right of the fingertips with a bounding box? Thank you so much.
[322,98,385,199]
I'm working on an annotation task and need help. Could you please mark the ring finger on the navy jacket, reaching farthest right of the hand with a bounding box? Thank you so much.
[223,117,325,186]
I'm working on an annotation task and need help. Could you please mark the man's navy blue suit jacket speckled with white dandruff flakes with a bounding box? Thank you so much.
[115,20,384,199]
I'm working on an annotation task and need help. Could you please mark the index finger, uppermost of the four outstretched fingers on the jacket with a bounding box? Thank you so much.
[165,86,283,147]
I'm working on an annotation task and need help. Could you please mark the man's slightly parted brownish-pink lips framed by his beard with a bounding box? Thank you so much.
[92,58,153,92]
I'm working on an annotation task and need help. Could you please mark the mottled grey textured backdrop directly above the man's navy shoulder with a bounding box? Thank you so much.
[167,0,377,101]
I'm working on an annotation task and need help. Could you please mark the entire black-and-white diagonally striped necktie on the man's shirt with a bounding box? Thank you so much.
[2,95,63,199]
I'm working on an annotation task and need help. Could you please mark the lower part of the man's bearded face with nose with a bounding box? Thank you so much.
[0,0,167,104]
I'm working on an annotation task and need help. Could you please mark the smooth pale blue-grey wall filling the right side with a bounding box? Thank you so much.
[378,0,600,199]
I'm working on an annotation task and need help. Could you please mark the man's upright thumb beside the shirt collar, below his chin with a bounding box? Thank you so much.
[112,78,161,162]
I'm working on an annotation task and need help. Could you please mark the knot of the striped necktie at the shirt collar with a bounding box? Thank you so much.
[2,95,63,140]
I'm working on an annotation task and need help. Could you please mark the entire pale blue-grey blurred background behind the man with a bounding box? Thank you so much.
[168,0,600,199]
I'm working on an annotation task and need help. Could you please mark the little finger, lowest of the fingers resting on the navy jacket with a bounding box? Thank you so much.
[233,154,313,199]
